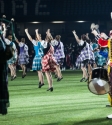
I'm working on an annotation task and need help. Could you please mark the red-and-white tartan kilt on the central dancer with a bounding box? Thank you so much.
[42,53,59,72]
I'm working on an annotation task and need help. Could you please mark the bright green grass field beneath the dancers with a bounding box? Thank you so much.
[0,71,112,125]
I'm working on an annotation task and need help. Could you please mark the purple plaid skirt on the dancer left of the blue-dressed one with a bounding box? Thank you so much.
[18,53,29,65]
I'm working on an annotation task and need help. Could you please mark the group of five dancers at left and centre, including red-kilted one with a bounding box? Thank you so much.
[2,23,65,91]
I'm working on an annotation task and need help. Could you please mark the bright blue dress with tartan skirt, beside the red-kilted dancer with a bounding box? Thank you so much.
[32,42,43,71]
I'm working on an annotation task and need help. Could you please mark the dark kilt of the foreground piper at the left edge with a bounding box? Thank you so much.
[0,62,9,115]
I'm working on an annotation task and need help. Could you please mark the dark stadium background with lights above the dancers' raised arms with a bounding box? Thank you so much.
[0,0,112,44]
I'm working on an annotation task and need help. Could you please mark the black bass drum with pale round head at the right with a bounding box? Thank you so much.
[88,67,110,95]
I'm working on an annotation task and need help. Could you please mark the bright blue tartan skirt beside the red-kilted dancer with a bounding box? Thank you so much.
[32,55,42,71]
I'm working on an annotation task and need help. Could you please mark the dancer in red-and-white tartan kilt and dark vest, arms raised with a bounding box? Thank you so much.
[42,29,62,92]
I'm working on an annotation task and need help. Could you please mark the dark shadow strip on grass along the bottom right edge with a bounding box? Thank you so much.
[42,117,112,125]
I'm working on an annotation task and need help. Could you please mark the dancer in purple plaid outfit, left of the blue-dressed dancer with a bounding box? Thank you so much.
[13,34,29,78]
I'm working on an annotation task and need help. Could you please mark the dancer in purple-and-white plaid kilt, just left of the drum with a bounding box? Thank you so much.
[73,31,95,81]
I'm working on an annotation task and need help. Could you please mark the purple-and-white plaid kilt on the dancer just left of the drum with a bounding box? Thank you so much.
[76,46,95,67]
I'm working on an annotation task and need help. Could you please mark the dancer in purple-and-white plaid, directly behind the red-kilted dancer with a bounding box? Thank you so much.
[51,35,65,81]
